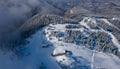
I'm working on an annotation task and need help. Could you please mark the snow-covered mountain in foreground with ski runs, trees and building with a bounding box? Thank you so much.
[0,14,120,69]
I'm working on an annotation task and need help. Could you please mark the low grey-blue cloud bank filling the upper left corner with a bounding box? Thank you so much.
[0,0,40,46]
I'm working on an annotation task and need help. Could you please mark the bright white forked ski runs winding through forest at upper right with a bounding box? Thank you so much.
[78,17,120,51]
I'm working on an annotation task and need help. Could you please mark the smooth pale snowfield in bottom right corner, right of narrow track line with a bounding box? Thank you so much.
[94,53,120,69]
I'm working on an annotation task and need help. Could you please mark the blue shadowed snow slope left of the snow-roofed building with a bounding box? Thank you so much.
[0,30,60,69]
